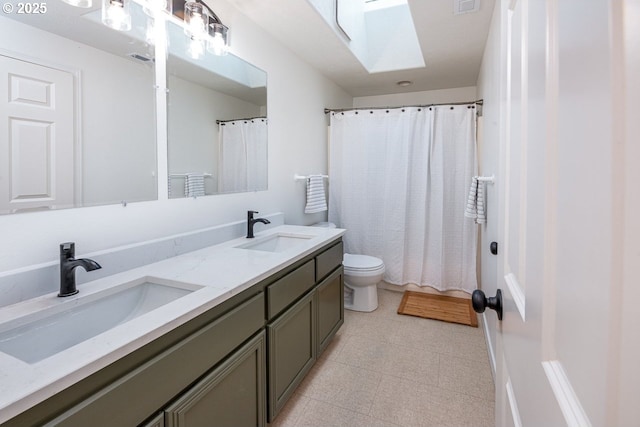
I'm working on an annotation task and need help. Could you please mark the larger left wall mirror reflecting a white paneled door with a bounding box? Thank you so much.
[0,0,158,214]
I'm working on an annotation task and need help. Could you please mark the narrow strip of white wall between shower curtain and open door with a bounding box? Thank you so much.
[477,0,501,373]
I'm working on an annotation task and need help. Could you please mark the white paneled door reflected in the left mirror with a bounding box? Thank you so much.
[0,55,75,213]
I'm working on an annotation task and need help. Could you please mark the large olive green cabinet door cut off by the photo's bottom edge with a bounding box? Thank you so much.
[165,332,266,427]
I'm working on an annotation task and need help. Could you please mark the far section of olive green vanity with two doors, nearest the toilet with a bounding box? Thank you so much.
[266,241,344,422]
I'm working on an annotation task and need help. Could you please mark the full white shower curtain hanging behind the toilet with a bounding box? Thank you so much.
[329,105,477,292]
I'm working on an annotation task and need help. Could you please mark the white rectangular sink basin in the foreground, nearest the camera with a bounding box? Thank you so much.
[0,277,201,363]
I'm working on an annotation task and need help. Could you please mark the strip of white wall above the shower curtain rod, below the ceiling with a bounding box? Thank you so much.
[353,86,476,108]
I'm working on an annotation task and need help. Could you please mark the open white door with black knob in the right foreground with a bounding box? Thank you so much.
[496,0,640,426]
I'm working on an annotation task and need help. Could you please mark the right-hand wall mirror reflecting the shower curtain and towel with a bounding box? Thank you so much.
[167,16,267,198]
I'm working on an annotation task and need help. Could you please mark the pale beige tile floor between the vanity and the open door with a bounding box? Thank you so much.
[271,289,495,427]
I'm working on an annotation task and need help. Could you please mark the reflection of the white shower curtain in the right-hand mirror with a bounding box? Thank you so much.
[218,117,267,193]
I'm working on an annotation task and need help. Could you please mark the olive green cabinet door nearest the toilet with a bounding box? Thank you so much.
[316,267,344,355]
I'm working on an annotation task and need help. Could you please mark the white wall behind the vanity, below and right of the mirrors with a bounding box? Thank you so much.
[0,0,352,276]
